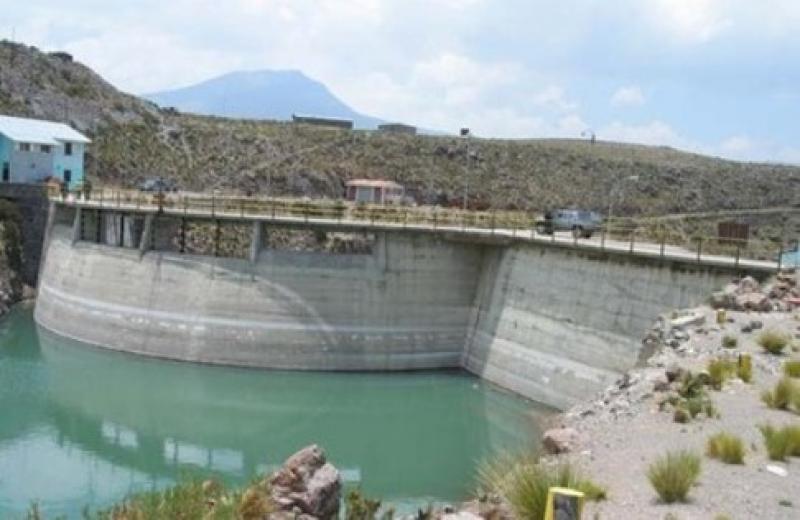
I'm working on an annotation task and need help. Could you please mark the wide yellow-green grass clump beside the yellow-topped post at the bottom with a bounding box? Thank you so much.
[478,455,606,519]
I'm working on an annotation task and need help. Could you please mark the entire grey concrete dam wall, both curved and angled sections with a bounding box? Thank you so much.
[35,203,763,408]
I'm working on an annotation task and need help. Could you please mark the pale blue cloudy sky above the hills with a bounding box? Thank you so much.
[0,0,800,164]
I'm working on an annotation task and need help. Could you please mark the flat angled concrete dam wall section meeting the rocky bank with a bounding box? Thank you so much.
[462,245,731,409]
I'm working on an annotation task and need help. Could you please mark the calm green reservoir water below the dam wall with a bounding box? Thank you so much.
[0,309,548,518]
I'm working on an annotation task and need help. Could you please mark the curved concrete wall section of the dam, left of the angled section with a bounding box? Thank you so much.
[35,217,482,370]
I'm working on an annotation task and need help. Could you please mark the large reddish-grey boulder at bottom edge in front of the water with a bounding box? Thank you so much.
[269,445,341,519]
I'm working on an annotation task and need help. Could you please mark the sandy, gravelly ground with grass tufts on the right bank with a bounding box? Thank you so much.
[562,308,800,520]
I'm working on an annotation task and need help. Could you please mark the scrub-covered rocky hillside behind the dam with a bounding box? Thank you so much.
[0,42,800,215]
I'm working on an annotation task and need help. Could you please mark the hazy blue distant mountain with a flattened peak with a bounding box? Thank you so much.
[144,70,382,128]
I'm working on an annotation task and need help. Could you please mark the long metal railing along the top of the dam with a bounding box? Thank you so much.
[50,188,785,272]
